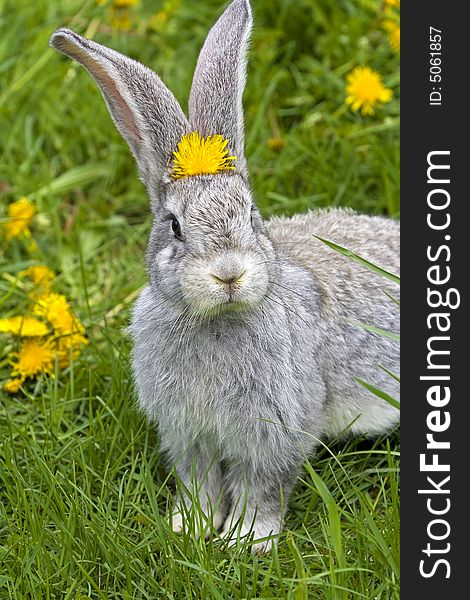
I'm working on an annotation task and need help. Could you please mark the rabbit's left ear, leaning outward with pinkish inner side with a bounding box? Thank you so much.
[50,29,189,184]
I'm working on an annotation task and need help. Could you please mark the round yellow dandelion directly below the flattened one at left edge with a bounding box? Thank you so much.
[10,338,56,380]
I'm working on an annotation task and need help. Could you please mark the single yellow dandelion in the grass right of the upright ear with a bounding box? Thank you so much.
[346,67,392,115]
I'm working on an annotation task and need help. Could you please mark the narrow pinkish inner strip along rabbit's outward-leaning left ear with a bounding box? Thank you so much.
[56,36,142,150]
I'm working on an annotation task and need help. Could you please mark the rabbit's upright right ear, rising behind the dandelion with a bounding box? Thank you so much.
[189,0,252,177]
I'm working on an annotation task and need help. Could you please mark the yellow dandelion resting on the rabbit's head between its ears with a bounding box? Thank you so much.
[171,131,236,179]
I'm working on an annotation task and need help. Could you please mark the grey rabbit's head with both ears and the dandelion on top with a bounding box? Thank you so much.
[51,0,276,314]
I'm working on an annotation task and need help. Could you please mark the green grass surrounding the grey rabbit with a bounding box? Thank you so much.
[0,0,399,600]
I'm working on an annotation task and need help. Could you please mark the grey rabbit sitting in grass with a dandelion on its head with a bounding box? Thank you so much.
[50,0,399,552]
